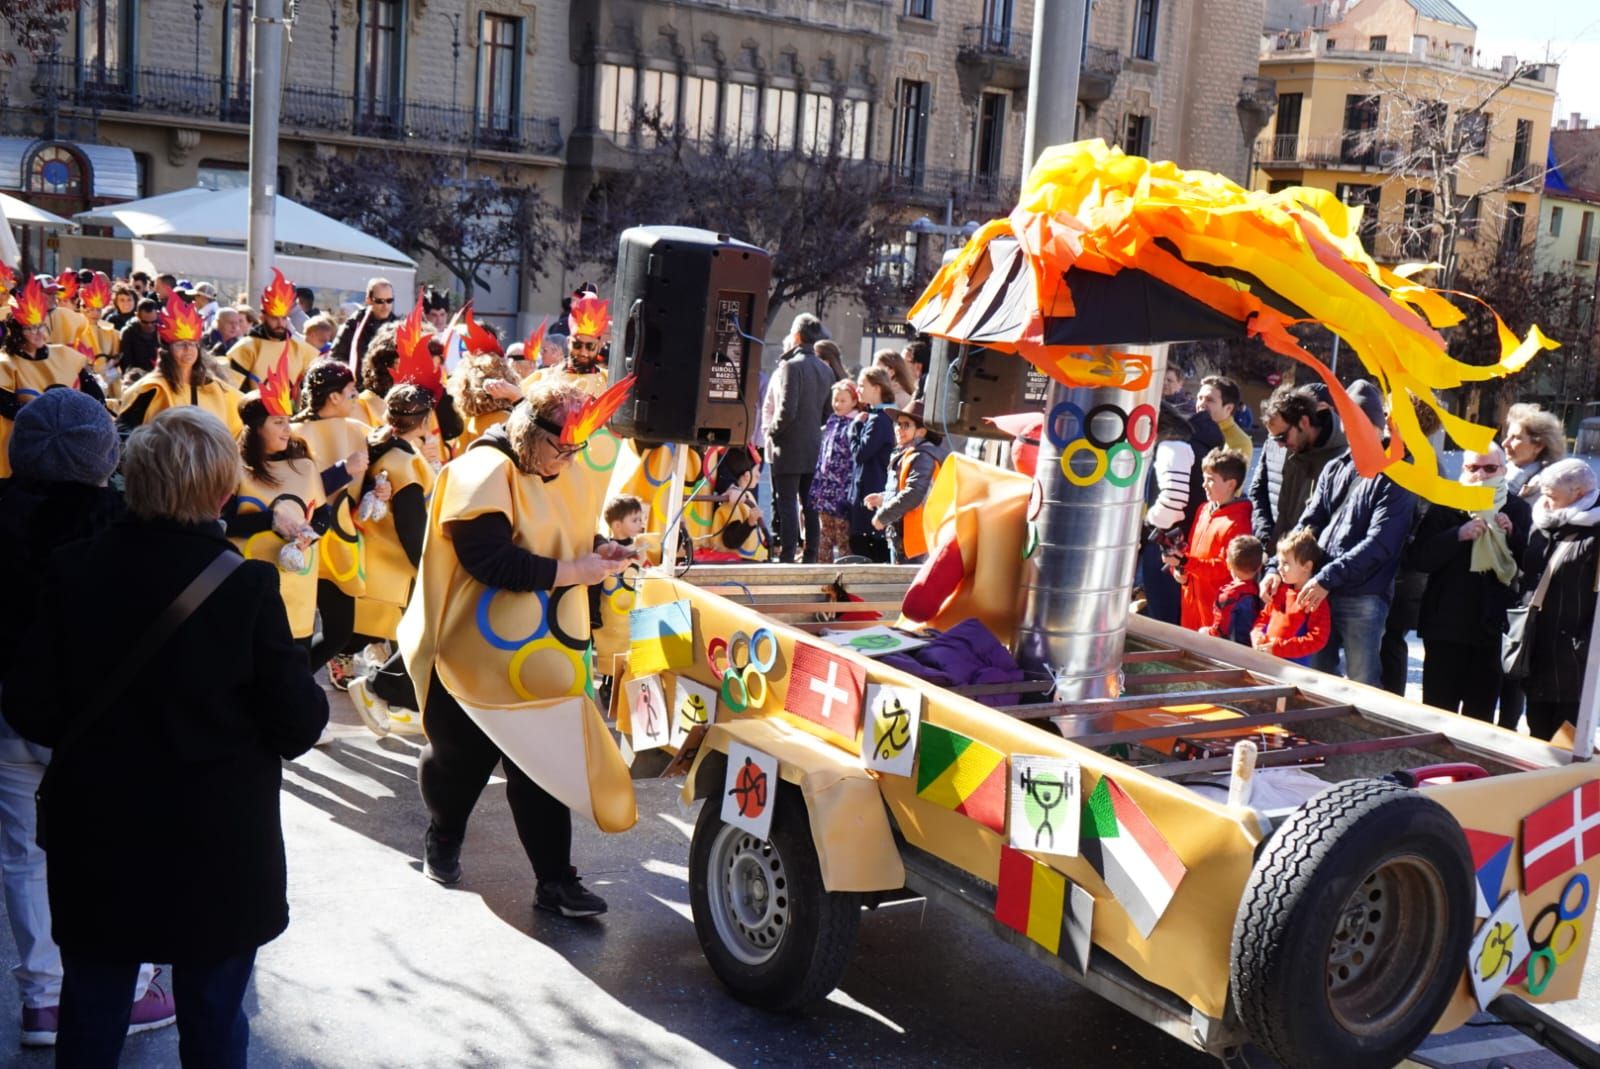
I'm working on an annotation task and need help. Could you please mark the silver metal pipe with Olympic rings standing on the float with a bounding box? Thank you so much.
[1018,344,1168,701]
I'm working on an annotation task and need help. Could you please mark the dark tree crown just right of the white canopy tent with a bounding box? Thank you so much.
[304,149,560,299]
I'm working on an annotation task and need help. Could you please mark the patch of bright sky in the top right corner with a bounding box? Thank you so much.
[1454,0,1600,126]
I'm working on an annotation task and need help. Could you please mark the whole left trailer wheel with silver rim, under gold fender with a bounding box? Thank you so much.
[690,784,861,1010]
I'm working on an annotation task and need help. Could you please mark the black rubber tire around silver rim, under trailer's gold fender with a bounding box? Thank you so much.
[690,784,862,1011]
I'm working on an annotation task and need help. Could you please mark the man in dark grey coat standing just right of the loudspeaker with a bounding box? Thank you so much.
[766,312,834,563]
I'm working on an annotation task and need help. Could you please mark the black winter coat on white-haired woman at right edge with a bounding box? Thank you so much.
[1522,512,1600,703]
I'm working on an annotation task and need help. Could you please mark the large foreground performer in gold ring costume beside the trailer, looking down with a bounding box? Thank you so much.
[400,379,637,917]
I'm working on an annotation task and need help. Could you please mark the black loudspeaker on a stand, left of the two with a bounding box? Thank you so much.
[610,226,773,445]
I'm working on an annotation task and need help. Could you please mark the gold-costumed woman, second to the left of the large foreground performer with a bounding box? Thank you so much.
[294,360,389,685]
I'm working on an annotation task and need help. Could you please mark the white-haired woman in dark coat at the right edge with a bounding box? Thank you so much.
[1522,459,1600,739]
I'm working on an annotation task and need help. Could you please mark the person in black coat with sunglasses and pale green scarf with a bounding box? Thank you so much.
[1406,445,1533,722]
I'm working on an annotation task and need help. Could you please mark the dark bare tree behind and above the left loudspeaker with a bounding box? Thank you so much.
[566,115,888,325]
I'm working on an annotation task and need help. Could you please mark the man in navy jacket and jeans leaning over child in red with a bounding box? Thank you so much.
[1262,379,1416,687]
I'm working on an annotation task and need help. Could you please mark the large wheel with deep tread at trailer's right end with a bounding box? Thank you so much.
[1230,779,1474,1069]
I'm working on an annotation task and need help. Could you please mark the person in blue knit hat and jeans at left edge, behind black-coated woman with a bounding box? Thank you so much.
[0,389,174,1047]
